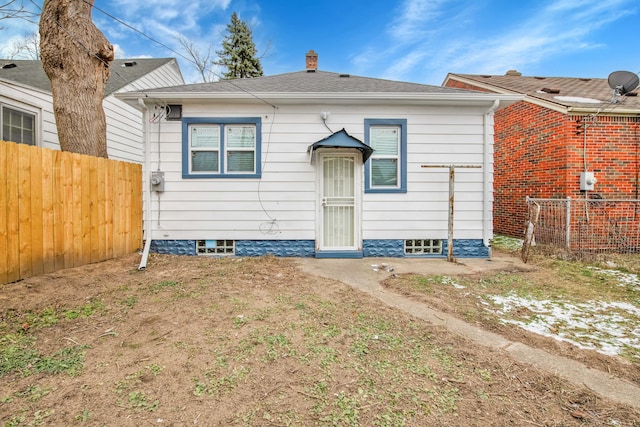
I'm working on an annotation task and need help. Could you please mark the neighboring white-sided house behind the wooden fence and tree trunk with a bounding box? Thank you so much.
[0,58,184,163]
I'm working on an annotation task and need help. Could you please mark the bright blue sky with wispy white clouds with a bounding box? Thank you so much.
[0,0,640,85]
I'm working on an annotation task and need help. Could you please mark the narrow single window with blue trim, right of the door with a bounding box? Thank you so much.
[364,119,407,193]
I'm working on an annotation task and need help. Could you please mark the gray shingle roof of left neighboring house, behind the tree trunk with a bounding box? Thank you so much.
[0,58,173,96]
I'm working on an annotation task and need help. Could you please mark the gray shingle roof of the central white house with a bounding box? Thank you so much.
[144,71,470,94]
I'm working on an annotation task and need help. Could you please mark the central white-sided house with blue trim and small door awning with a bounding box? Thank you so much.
[117,50,519,257]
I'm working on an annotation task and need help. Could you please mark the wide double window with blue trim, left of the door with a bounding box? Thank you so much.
[182,117,262,178]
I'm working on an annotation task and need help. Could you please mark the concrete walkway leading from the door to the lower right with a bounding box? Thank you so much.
[295,255,640,409]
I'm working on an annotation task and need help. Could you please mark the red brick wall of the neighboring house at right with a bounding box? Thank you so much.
[447,80,640,237]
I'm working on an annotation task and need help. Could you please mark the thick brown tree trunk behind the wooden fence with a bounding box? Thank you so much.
[40,0,114,157]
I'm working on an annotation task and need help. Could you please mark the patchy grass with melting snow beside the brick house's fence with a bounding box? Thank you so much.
[387,238,640,363]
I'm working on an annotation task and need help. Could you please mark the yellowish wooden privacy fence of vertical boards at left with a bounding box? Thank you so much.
[0,141,142,283]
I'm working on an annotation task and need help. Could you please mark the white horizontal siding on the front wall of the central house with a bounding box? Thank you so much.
[145,104,491,246]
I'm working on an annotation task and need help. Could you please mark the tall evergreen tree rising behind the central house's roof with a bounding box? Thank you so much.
[216,12,263,80]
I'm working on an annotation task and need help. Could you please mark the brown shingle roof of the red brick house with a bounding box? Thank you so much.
[448,73,640,110]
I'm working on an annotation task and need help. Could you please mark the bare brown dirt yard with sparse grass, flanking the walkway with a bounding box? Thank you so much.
[0,254,640,426]
